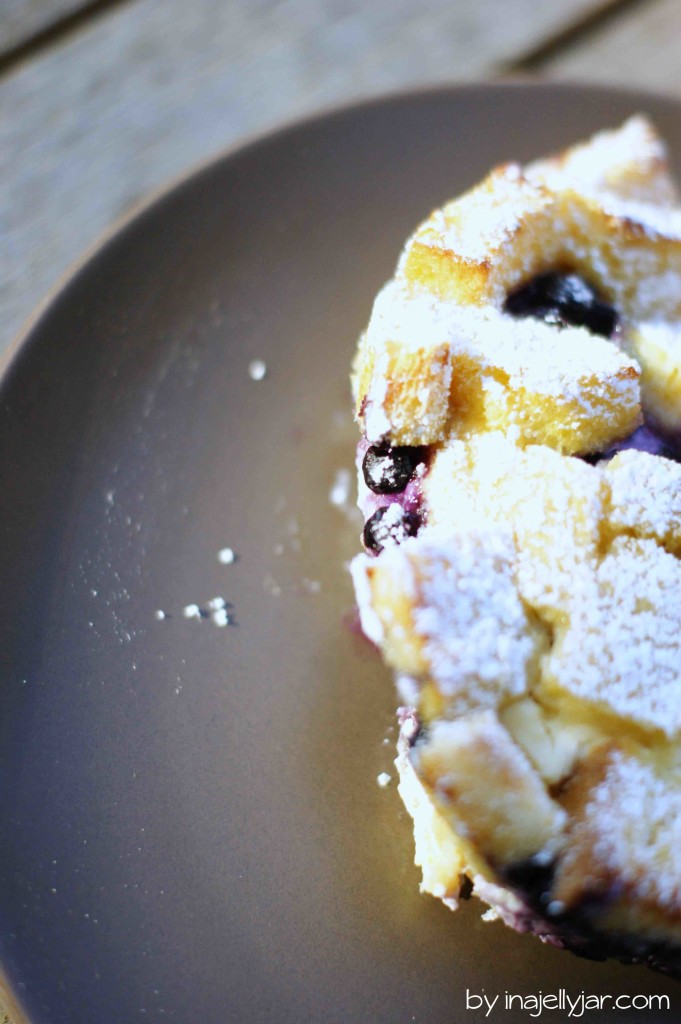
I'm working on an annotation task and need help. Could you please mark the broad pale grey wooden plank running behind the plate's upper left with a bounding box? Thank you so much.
[0,0,602,356]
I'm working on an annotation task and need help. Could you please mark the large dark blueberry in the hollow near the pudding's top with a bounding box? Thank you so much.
[504,271,619,338]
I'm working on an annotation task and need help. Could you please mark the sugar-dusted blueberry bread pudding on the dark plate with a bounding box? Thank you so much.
[351,116,681,971]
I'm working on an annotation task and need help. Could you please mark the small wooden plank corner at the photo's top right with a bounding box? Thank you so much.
[541,0,681,96]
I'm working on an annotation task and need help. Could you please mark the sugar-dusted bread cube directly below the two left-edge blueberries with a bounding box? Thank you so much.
[352,529,545,715]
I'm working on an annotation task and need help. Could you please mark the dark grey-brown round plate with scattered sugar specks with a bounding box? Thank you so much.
[0,85,681,1024]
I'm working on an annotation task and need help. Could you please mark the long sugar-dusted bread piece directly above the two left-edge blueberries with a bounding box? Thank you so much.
[353,282,640,455]
